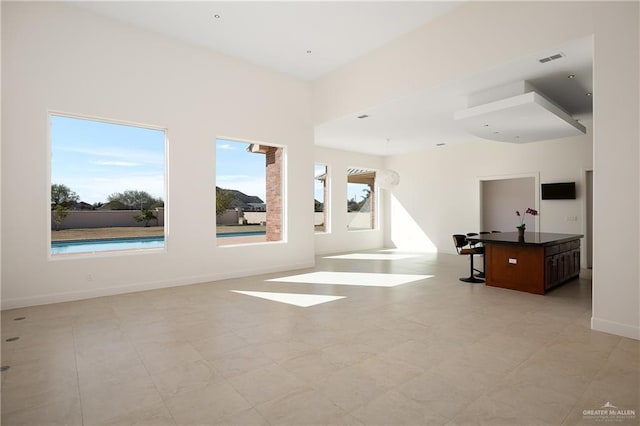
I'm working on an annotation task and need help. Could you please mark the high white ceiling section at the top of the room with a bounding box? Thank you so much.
[75,1,458,80]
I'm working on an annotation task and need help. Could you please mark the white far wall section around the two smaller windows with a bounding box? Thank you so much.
[309,147,384,254]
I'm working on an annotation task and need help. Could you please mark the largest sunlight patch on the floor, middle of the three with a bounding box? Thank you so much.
[267,271,433,287]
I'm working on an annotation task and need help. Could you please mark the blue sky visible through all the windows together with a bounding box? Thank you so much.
[51,115,362,204]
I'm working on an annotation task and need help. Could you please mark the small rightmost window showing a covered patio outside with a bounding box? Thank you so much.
[347,167,377,231]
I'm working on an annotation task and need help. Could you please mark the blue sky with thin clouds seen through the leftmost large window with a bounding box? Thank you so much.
[51,115,165,204]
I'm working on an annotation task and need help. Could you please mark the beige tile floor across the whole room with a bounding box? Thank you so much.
[1,252,640,426]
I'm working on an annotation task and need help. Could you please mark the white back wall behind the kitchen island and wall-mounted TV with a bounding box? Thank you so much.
[386,133,592,253]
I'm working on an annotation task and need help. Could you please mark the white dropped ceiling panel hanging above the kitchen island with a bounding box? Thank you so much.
[454,81,586,143]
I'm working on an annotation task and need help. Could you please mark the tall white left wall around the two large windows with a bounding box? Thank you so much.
[2,2,314,308]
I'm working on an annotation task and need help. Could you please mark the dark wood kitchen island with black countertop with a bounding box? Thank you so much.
[469,232,583,294]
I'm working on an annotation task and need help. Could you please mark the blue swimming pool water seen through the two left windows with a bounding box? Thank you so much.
[51,231,266,254]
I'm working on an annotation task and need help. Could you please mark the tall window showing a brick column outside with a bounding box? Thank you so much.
[216,139,284,245]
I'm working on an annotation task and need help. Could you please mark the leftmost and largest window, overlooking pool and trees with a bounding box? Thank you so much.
[49,114,165,255]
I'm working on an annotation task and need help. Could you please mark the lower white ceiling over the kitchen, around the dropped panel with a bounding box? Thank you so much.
[315,38,593,155]
